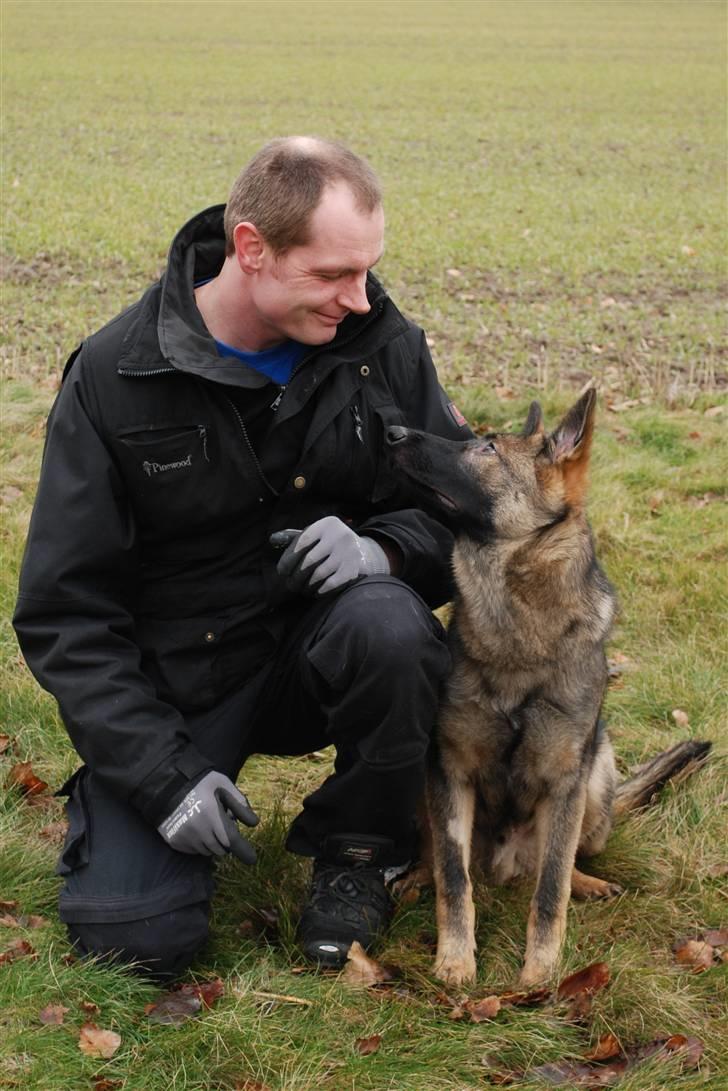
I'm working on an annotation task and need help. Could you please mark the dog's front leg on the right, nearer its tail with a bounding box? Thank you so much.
[521,779,586,986]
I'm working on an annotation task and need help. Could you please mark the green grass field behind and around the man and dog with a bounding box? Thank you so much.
[0,0,728,1091]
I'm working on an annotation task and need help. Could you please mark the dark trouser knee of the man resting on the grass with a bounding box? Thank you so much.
[68,903,210,981]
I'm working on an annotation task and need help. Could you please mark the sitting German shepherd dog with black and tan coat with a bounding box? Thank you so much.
[386,389,711,985]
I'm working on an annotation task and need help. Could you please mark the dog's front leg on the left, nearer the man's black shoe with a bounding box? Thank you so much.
[427,754,476,985]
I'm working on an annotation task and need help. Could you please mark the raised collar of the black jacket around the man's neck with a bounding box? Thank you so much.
[120,204,407,387]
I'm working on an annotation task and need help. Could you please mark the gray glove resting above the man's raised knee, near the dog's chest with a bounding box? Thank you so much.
[271,515,390,595]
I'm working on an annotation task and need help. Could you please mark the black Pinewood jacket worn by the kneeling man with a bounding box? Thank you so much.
[14,205,469,823]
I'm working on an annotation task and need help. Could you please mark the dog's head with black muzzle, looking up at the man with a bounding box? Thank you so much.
[386,388,596,541]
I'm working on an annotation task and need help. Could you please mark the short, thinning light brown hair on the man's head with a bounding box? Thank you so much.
[225,136,382,256]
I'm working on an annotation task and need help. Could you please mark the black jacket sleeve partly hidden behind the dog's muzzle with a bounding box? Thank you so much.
[358,325,473,609]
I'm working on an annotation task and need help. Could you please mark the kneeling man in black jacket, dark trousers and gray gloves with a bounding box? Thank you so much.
[15,137,469,978]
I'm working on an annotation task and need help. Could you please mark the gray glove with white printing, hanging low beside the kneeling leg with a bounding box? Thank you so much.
[157,772,260,864]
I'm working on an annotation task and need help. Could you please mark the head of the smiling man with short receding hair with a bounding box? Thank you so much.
[225,136,384,348]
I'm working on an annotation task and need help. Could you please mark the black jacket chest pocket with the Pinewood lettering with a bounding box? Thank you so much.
[117,423,215,535]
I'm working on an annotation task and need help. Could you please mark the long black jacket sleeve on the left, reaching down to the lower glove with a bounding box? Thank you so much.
[14,349,212,825]
